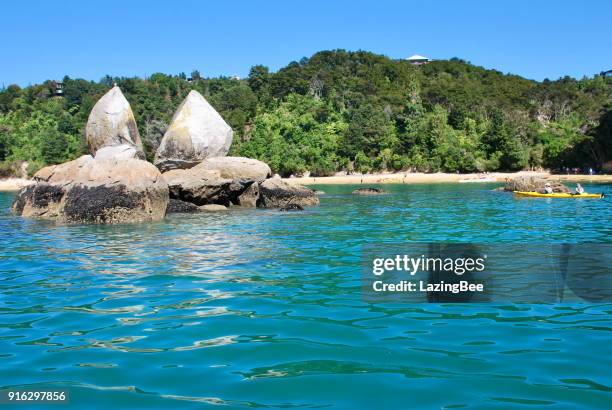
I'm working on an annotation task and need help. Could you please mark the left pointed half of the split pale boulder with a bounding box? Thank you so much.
[85,86,144,158]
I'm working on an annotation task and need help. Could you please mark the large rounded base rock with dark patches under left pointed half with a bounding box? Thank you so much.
[13,155,168,223]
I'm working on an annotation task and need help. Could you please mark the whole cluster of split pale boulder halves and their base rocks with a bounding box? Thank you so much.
[13,86,319,223]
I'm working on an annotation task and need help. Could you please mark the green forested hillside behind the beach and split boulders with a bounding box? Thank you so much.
[0,50,612,176]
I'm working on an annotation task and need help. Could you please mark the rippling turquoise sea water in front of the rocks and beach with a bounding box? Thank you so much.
[0,184,612,409]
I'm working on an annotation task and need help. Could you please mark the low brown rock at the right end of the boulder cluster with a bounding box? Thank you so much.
[257,177,319,208]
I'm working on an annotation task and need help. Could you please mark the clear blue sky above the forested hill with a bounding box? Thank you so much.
[0,0,612,85]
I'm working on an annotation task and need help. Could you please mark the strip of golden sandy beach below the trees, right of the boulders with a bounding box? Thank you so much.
[283,171,612,185]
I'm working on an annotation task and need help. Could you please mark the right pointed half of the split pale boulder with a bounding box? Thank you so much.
[155,90,233,172]
